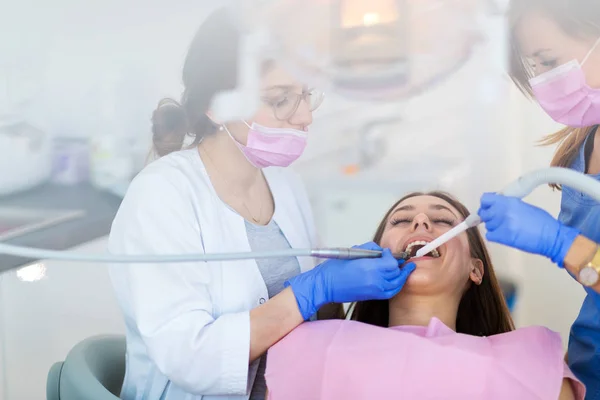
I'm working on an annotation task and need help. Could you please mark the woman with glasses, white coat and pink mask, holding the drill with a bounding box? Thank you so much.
[109,9,414,400]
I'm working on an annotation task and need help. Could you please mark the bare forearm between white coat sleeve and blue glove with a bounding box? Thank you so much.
[250,287,304,362]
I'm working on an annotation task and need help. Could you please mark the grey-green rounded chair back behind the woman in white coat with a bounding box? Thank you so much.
[46,335,125,400]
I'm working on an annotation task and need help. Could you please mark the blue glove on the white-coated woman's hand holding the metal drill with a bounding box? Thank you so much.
[285,243,416,320]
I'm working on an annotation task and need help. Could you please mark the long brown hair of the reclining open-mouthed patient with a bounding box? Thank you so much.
[352,191,515,336]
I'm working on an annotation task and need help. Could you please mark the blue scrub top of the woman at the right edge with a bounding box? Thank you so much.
[558,126,600,400]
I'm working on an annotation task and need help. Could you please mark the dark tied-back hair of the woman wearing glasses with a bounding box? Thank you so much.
[152,7,240,157]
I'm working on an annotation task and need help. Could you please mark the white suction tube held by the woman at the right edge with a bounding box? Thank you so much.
[416,167,600,257]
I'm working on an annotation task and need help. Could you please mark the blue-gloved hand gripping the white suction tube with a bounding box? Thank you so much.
[479,193,579,267]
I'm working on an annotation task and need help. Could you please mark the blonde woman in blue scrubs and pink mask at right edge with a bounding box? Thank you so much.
[479,0,600,400]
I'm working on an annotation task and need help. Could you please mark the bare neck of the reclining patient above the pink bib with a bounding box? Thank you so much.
[389,293,460,330]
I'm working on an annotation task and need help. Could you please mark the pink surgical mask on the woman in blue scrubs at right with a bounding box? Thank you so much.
[529,39,600,127]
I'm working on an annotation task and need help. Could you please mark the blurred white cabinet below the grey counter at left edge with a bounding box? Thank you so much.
[0,238,124,400]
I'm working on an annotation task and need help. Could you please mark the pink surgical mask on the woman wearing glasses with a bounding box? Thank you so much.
[223,121,308,168]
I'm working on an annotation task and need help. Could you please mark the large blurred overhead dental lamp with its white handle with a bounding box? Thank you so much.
[212,0,486,120]
